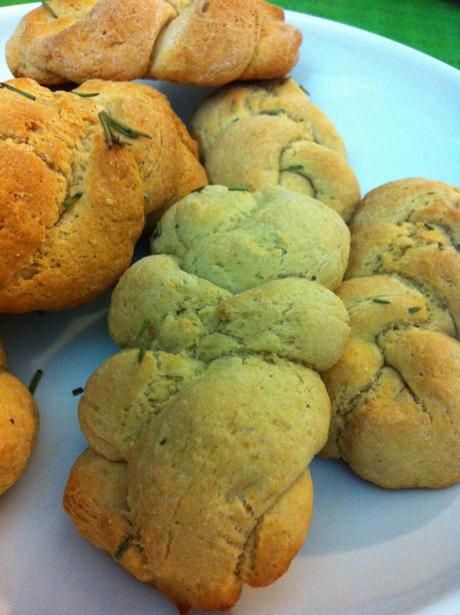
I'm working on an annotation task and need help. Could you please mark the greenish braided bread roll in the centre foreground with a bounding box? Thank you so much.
[64,186,349,611]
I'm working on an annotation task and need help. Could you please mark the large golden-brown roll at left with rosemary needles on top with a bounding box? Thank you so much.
[0,79,206,312]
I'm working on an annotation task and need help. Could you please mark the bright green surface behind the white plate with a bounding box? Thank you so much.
[0,0,460,68]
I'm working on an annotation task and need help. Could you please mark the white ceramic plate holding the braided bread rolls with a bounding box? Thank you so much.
[0,5,460,615]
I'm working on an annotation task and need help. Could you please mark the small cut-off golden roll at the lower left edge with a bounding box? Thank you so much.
[0,342,38,495]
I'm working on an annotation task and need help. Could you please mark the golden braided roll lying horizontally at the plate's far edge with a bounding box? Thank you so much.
[6,0,302,86]
